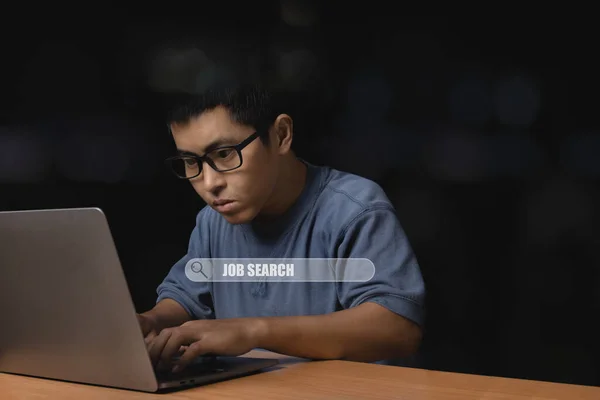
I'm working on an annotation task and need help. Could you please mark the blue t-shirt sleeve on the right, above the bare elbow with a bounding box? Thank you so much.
[337,206,425,326]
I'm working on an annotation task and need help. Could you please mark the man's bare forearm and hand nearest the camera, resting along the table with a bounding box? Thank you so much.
[148,302,421,372]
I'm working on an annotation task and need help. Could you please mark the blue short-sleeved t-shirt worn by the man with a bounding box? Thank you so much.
[157,163,425,332]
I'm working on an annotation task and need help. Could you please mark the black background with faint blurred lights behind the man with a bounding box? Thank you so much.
[0,1,600,385]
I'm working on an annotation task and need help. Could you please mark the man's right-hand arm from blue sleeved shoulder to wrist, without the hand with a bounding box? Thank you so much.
[268,203,425,361]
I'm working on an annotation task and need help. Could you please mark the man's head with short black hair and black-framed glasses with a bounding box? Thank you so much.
[169,86,293,224]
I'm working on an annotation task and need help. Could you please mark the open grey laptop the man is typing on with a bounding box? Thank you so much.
[0,208,277,392]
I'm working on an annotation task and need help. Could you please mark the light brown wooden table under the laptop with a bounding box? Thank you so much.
[0,351,600,400]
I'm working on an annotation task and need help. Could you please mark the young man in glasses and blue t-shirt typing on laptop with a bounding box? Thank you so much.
[138,87,425,376]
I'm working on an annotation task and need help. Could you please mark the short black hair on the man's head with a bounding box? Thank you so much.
[167,84,281,145]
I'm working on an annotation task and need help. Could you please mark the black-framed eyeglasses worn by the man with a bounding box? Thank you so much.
[165,132,259,179]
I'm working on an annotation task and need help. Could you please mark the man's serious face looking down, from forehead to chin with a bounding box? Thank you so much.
[171,107,278,224]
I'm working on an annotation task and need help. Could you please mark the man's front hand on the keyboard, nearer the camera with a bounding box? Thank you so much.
[148,318,261,372]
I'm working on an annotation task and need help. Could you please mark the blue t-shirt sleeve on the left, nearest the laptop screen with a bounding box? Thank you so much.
[156,214,214,319]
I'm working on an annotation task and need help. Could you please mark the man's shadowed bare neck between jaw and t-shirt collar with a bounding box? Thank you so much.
[257,157,307,220]
